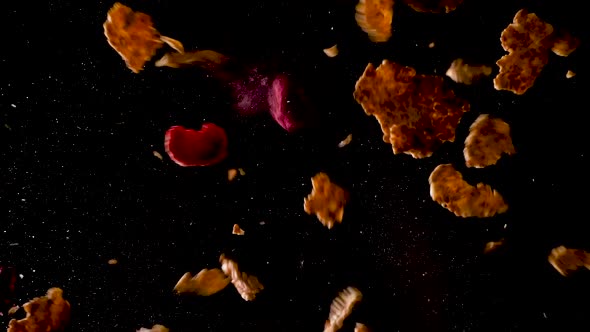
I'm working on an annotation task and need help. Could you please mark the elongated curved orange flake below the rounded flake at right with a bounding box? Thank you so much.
[428,164,508,218]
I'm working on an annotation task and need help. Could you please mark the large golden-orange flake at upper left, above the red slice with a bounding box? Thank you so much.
[103,2,164,74]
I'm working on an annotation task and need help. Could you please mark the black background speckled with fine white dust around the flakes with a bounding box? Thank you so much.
[0,0,590,331]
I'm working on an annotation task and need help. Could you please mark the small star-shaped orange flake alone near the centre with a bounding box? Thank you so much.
[303,172,349,229]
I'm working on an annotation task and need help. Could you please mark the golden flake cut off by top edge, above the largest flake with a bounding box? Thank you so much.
[355,0,393,43]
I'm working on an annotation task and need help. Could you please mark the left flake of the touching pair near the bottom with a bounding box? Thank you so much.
[174,269,230,296]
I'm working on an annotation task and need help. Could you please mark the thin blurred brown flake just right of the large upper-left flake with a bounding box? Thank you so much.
[155,50,229,70]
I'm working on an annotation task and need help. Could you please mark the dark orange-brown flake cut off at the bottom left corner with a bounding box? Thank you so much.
[7,288,70,332]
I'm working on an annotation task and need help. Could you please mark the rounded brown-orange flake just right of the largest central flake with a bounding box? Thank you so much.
[463,114,516,168]
